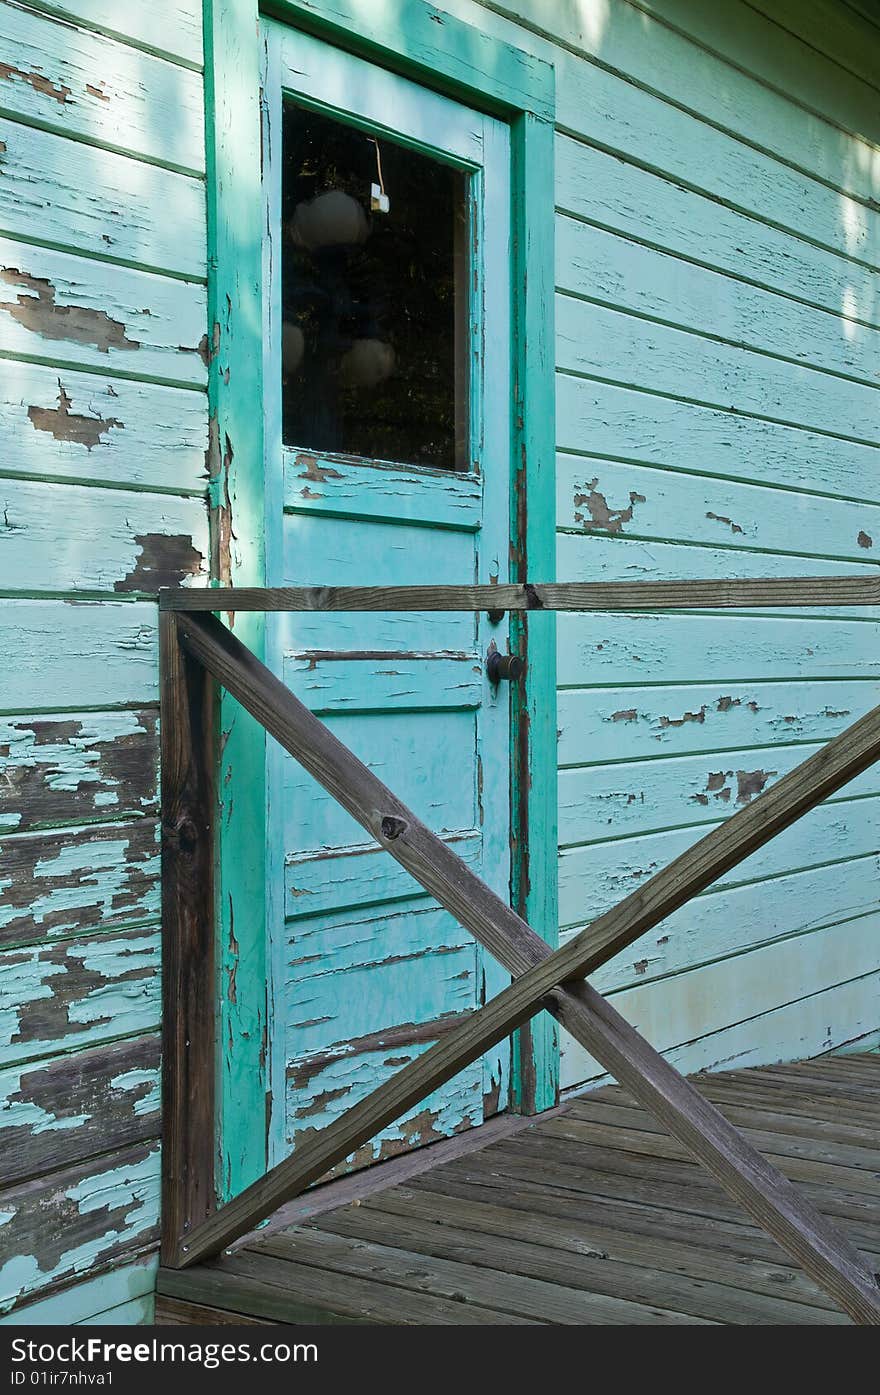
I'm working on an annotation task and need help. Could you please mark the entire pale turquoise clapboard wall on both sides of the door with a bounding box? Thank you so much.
[0,0,880,1322]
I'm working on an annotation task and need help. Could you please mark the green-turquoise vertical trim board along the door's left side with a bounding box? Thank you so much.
[204,0,266,1201]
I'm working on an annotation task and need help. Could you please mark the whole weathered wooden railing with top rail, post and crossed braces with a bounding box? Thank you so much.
[160,576,880,1324]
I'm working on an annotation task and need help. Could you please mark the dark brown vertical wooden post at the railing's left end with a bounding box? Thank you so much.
[159,612,216,1267]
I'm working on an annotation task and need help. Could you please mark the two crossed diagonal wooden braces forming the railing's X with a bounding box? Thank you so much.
[176,615,880,1324]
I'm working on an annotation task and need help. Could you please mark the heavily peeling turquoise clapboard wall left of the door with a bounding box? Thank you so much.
[0,0,208,1322]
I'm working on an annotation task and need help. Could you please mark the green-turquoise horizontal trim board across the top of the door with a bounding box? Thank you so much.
[259,0,554,120]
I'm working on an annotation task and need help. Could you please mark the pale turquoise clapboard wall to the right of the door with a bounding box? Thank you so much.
[445,0,880,1088]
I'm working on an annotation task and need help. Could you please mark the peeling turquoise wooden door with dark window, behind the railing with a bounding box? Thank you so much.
[264,24,510,1163]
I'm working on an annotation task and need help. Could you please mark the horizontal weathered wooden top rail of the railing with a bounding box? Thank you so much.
[159,576,880,612]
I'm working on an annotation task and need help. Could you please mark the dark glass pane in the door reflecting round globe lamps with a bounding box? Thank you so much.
[282,105,467,469]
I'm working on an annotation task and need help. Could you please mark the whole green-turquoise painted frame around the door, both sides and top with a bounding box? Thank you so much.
[204,0,559,1200]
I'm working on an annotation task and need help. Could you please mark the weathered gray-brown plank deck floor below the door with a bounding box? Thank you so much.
[156,1055,880,1325]
